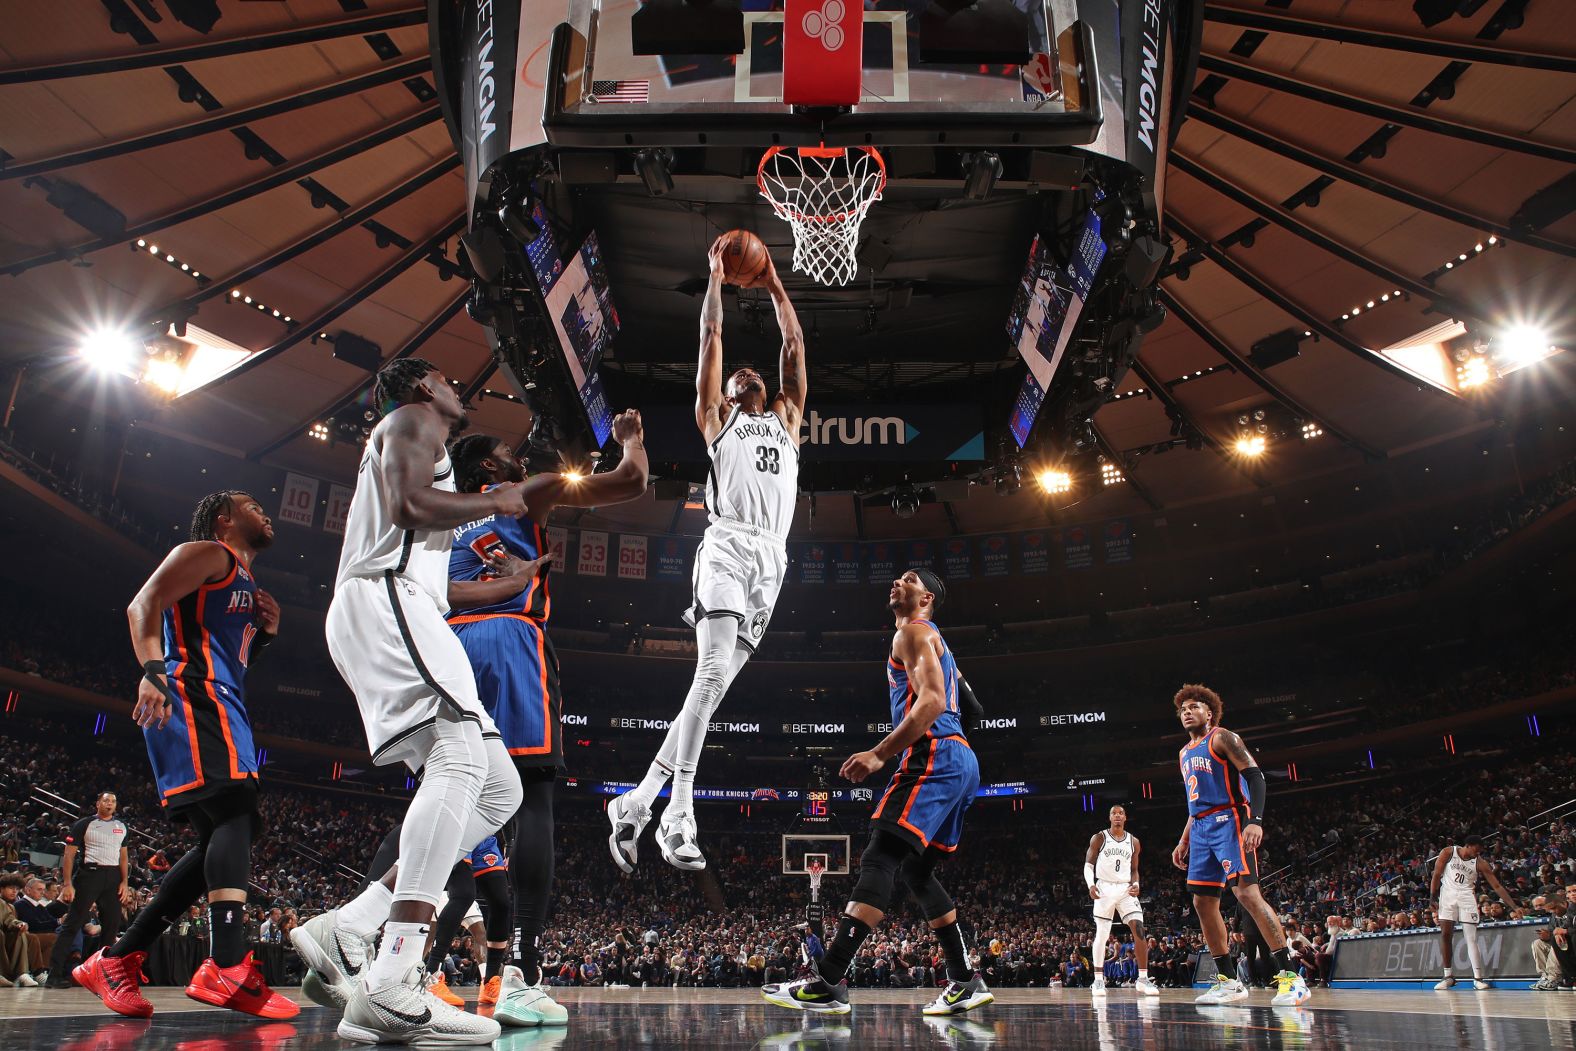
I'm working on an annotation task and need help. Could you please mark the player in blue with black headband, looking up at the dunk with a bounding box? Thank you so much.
[761,569,996,1015]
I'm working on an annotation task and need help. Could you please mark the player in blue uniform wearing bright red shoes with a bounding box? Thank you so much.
[74,490,301,1018]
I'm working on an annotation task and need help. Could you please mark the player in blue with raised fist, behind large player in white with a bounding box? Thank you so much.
[448,410,649,1026]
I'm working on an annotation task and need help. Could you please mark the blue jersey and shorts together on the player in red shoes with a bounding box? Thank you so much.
[142,544,258,807]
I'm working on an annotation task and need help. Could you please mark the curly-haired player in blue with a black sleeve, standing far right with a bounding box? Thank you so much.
[1171,684,1308,1007]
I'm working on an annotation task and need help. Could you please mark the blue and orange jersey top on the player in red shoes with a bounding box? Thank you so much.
[164,547,258,696]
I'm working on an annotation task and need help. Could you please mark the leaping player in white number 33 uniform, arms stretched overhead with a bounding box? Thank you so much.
[607,236,807,871]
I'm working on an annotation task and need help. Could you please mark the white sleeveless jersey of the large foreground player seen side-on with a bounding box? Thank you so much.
[334,424,454,611]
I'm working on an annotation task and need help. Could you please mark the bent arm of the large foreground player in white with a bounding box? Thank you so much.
[383,406,525,529]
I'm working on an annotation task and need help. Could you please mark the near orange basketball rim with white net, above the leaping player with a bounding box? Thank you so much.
[755,147,886,285]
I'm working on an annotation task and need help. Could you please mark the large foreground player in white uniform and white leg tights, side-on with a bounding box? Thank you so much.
[307,358,525,1045]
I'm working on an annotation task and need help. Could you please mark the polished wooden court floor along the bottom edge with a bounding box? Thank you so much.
[0,988,1576,1051]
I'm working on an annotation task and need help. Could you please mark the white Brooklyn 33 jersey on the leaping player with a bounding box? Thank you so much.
[706,407,799,537]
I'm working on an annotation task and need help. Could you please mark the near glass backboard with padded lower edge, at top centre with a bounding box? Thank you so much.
[544,0,1102,148]
